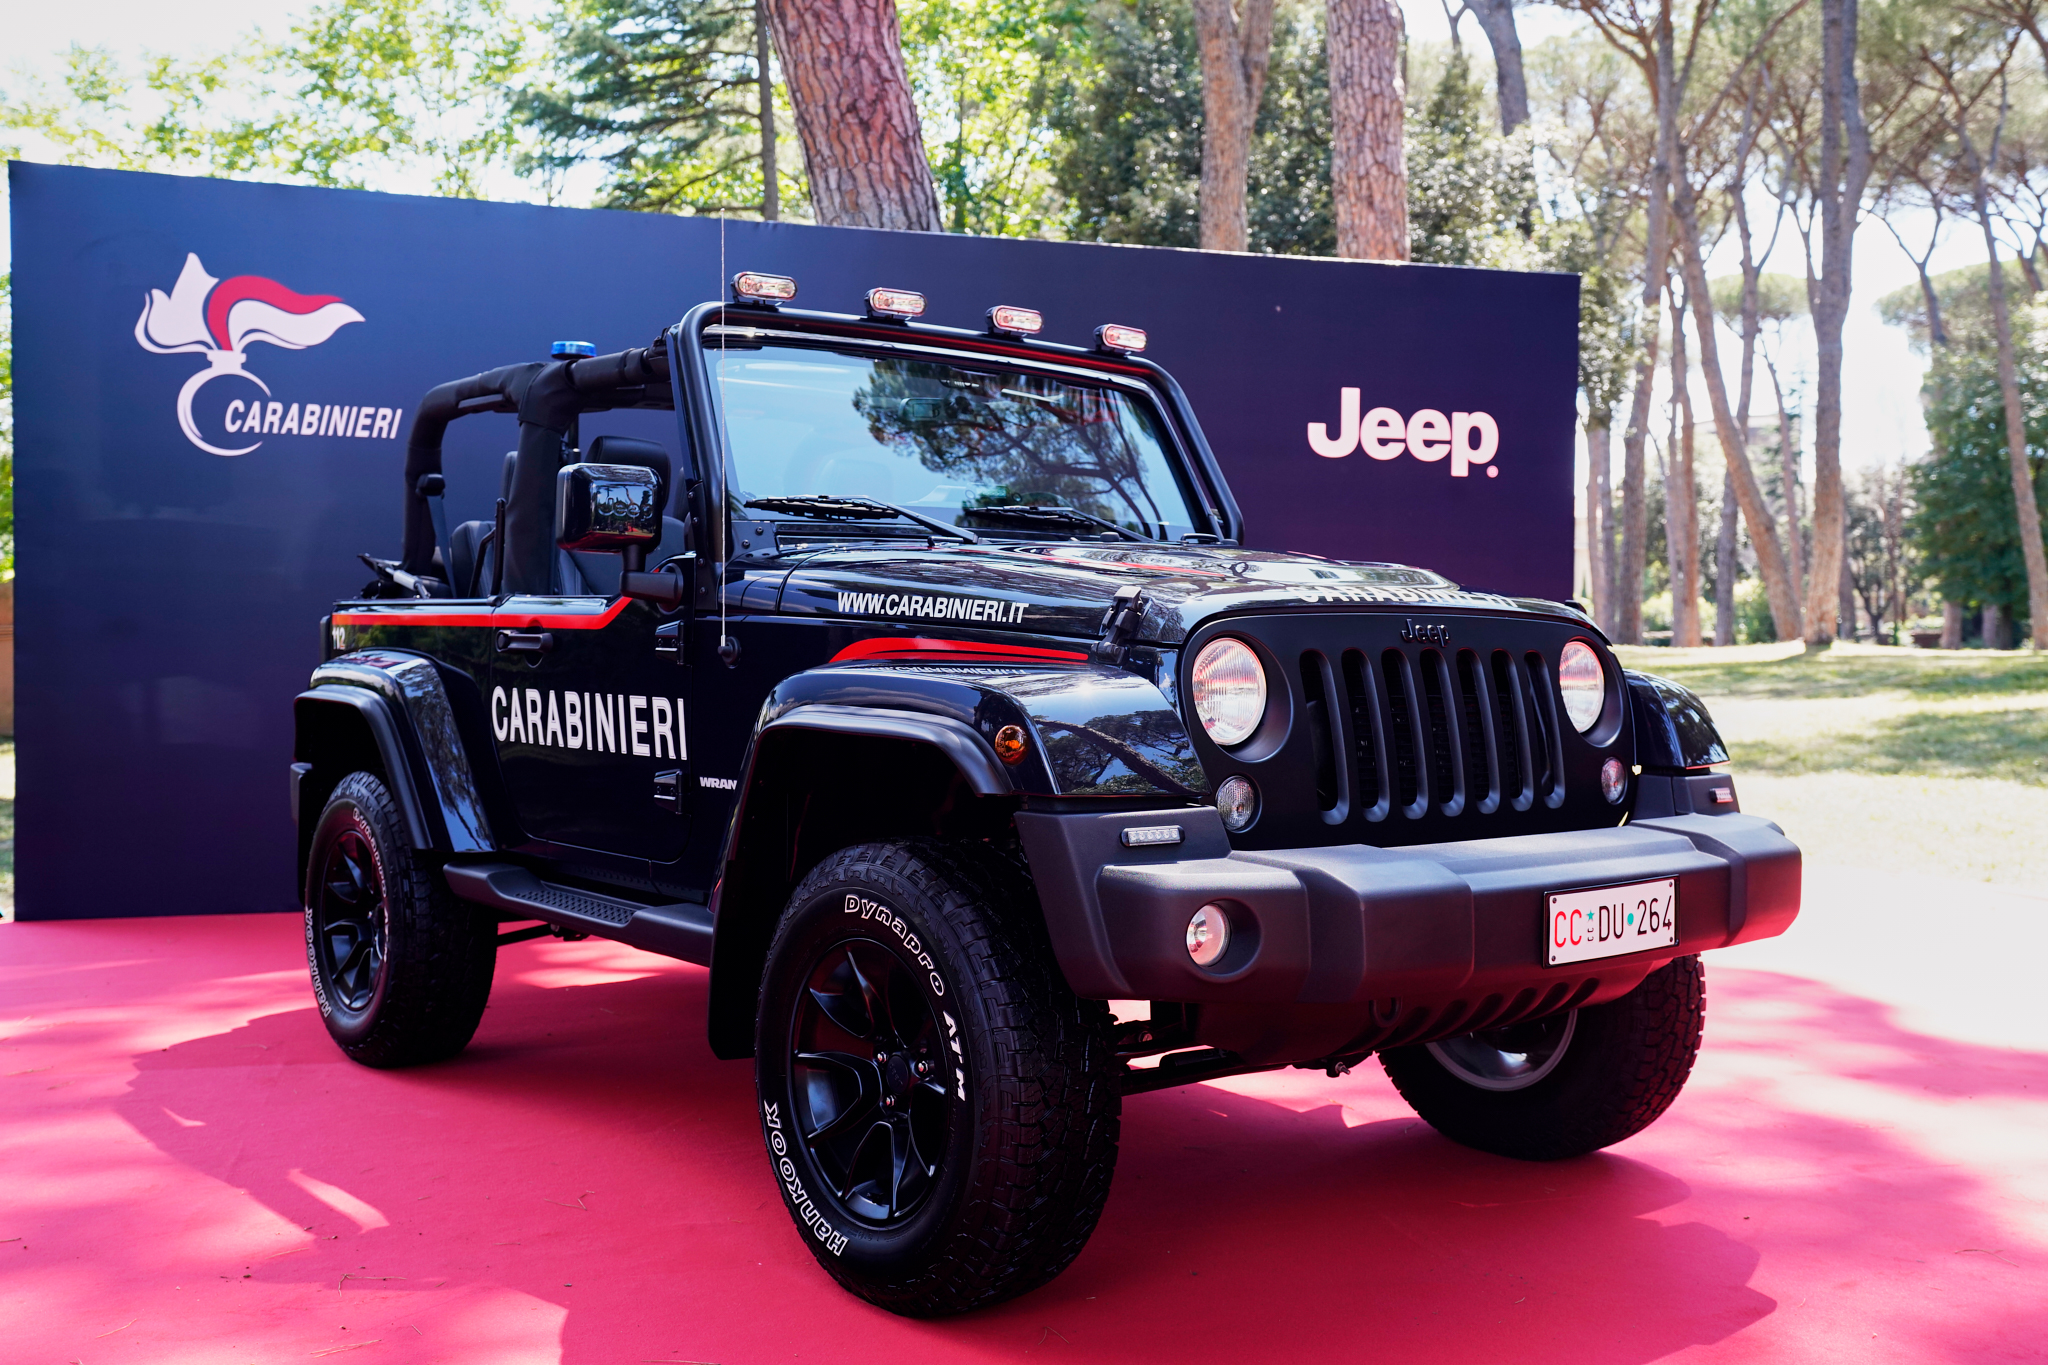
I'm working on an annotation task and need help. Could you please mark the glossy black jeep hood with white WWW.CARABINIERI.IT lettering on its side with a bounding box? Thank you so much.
[770,540,1595,645]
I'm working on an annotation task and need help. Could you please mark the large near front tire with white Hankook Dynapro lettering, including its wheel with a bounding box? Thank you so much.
[756,839,1122,1318]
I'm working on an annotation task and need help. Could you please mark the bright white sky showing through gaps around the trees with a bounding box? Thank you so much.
[0,0,1982,480]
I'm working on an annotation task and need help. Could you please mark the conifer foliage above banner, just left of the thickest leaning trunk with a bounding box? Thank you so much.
[516,0,803,213]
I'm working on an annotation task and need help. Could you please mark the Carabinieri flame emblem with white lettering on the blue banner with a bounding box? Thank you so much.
[135,252,403,454]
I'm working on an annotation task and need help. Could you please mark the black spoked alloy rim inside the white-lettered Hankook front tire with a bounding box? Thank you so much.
[791,937,948,1226]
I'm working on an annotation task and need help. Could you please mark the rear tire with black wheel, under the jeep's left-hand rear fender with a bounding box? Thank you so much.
[303,772,498,1066]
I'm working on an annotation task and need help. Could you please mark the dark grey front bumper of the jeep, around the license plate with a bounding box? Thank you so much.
[1016,808,1800,1010]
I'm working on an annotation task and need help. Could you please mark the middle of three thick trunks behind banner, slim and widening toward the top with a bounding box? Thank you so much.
[1194,0,1274,252]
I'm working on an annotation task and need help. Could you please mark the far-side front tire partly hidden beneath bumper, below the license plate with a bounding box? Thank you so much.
[1380,956,1706,1160]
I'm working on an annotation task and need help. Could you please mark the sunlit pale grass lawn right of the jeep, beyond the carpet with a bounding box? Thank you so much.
[1616,645,2048,894]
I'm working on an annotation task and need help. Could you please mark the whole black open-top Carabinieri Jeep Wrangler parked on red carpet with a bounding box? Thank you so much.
[291,274,1800,1316]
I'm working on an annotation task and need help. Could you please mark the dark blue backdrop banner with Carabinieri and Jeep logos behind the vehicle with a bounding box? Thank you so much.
[8,164,1577,919]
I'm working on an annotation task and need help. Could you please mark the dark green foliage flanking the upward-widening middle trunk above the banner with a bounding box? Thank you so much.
[1044,0,1337,256]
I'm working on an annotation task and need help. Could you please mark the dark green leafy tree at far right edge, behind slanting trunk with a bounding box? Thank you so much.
[1913,306,2048,616]
